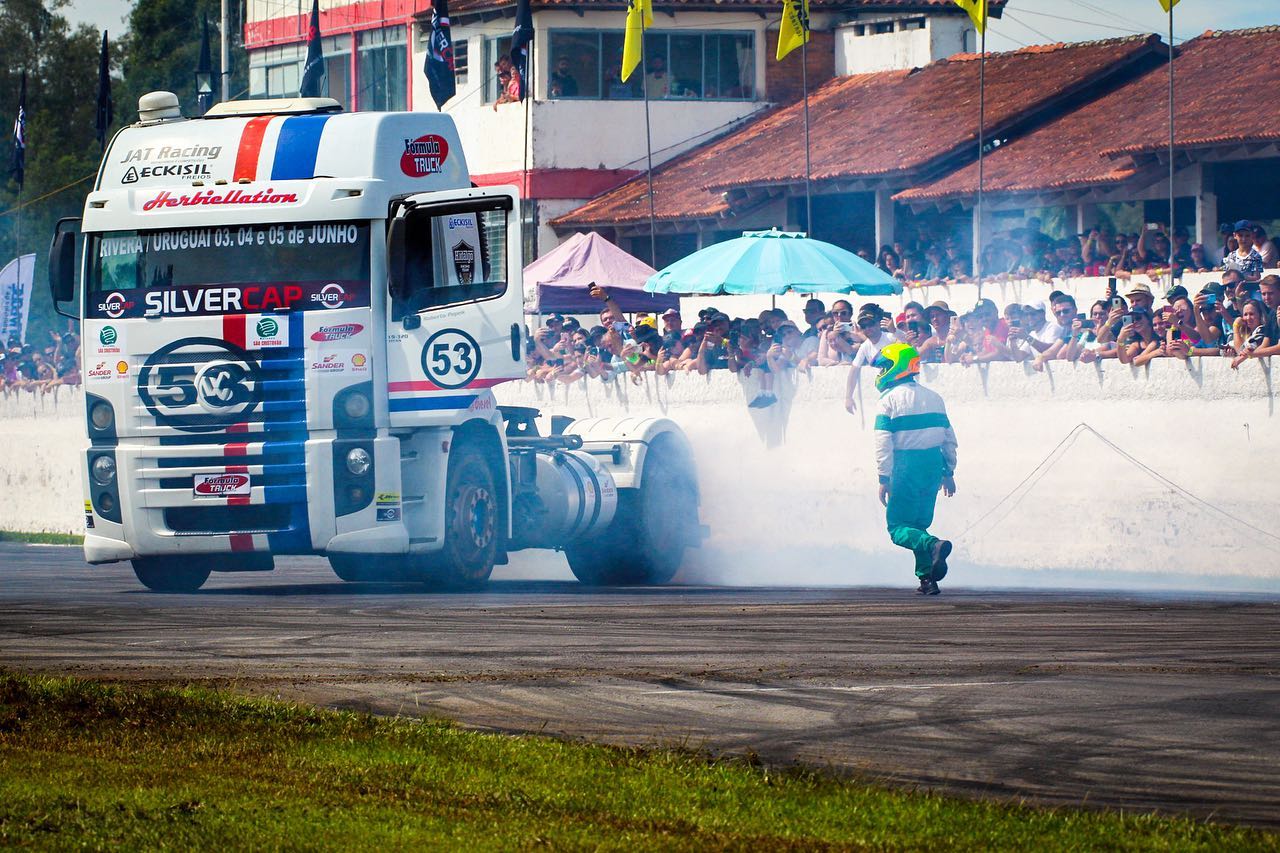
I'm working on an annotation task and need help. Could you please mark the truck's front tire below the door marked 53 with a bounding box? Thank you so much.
[424,441,502,589]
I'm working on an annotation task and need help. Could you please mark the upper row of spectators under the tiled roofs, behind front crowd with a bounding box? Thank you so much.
[859,218,1280,284]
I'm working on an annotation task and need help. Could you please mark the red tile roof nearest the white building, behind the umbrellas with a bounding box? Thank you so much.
[553,36,1160,225]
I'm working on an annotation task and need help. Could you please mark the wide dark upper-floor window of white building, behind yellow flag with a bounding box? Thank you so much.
[548,29,755,100]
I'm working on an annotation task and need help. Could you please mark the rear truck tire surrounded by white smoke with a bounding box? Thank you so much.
[564,434,699,587]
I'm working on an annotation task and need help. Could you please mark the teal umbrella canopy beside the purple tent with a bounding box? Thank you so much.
[644,229,902,296]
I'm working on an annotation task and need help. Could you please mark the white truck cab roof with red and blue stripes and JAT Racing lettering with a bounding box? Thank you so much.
[95,105,471,198]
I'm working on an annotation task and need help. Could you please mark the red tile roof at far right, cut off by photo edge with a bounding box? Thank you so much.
[896,27,1280,201]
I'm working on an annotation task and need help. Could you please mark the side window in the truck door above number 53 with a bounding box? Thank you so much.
[392,202,511,319]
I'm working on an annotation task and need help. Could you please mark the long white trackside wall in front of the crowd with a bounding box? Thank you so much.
[0,359,1280,590]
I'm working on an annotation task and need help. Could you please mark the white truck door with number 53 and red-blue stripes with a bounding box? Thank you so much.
[387,187,525,427]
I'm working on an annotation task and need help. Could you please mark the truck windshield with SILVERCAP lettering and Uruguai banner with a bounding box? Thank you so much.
[86,222,370,318]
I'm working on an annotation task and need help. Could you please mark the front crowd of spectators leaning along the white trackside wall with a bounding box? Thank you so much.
[526,269,1280,407]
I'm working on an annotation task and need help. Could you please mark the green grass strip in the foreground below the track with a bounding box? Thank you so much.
[0,674,1277,850]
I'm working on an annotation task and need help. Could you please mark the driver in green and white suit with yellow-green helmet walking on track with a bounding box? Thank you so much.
[872,343,956,596]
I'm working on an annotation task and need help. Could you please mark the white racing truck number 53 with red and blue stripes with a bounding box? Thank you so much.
[50,92,701,590]
